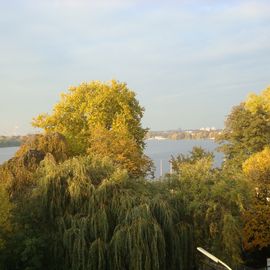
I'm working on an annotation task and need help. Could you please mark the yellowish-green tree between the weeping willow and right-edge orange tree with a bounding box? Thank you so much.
[168,149,250,267]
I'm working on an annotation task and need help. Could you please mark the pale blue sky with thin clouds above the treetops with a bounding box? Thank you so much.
[0,0,270,135]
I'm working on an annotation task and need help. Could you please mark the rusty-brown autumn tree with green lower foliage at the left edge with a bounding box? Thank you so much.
[0,133,69,269]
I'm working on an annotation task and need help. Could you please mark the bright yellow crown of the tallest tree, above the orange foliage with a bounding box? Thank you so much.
[33,80,147,149]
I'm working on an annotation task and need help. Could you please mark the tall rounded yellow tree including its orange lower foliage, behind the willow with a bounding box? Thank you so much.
[33,80,150,175]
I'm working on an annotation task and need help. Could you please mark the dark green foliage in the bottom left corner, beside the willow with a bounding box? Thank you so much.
[0,187,51,270]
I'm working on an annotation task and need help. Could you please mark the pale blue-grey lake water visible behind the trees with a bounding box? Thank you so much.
[0,140,223,177]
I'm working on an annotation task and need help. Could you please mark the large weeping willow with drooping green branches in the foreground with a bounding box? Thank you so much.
[36,156,192,270]
